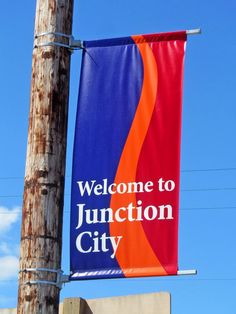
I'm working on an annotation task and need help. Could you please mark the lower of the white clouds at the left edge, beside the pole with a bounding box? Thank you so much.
[0,255,19,280]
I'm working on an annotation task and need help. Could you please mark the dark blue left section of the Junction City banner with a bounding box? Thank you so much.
[70,38,143,280]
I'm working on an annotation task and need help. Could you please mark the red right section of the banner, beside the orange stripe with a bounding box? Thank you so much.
[136,33,186,274]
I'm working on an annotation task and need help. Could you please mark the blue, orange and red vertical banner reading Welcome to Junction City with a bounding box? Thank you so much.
[70,32,186,280]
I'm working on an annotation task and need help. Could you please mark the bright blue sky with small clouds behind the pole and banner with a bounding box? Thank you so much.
[0,0,236,314]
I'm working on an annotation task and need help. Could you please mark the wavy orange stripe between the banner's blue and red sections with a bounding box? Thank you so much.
[110,36,167,277]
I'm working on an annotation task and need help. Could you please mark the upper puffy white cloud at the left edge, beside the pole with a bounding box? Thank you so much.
[0,206,20,233]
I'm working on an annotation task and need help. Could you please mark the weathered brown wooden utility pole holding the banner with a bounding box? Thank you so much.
[17,0,73,314]
